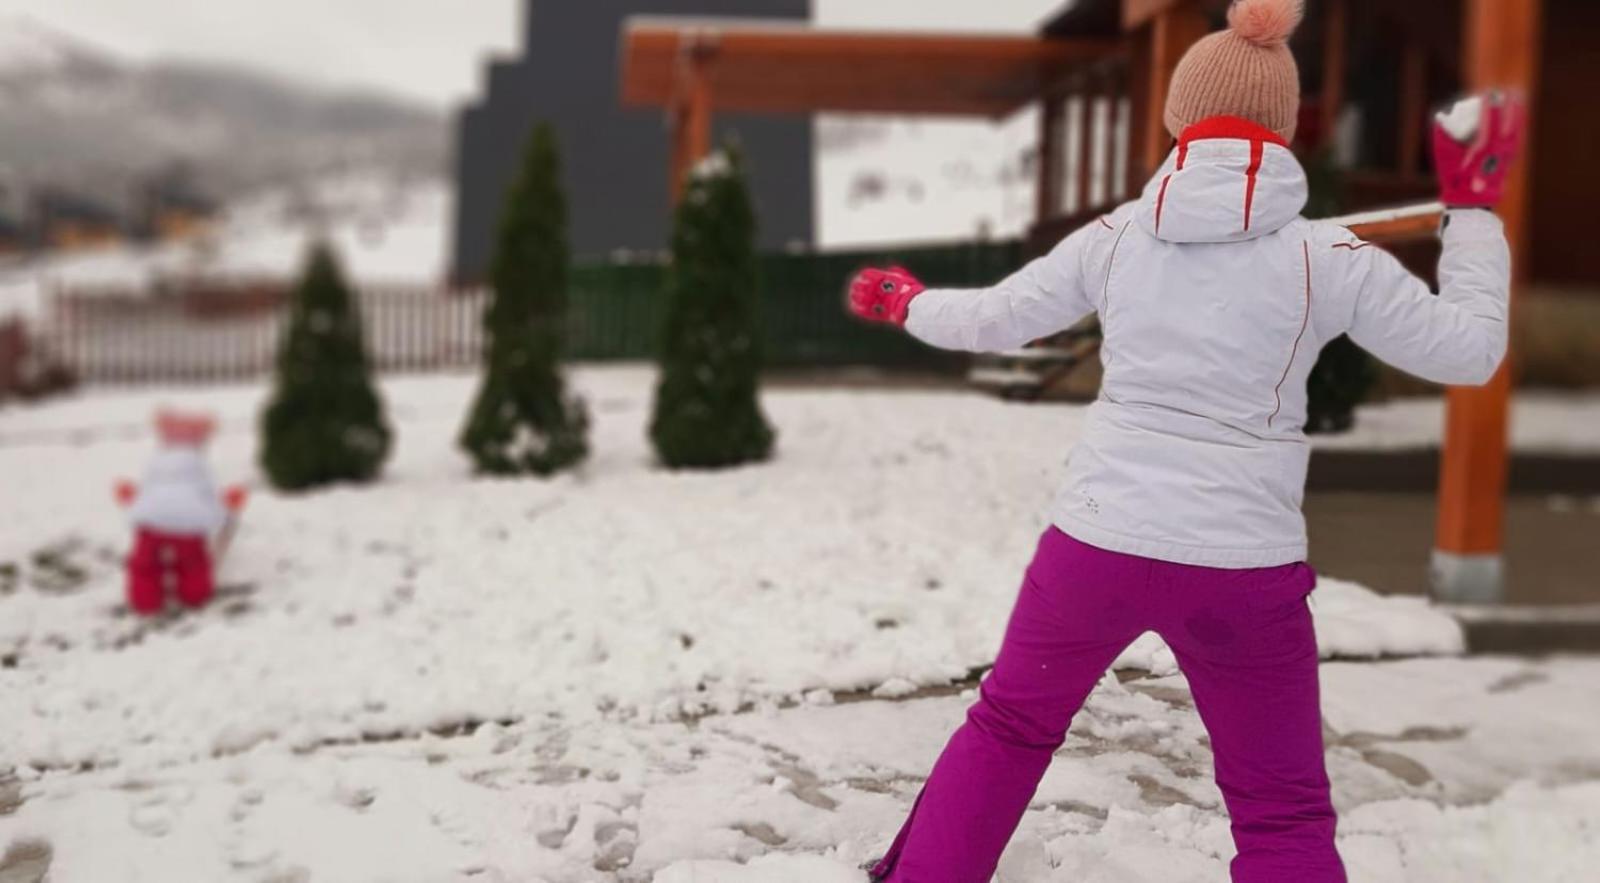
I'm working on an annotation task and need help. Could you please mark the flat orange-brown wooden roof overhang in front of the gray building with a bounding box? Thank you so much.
[622,18,1122,117]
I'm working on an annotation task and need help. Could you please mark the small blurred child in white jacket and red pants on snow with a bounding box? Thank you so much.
[117,410,245,616]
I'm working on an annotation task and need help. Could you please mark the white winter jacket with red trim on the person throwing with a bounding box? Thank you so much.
[906,118,1510,568]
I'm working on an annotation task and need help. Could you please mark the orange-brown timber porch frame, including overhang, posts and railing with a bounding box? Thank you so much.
[622,0,1542,600]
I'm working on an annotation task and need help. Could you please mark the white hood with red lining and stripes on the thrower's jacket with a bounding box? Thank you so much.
[1136,117,1307,243]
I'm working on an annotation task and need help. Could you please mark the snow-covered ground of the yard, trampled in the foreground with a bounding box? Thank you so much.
[0,368,1600,883]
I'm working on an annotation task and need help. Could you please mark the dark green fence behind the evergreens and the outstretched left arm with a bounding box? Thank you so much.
[568,242,1022,368]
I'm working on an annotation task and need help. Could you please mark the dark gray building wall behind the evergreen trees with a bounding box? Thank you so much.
[453,0,813,280]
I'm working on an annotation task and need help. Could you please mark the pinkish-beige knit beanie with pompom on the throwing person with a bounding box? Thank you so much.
[1165,0,1306,141]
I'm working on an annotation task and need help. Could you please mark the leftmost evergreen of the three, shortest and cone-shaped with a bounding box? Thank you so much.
[261,243,390,491]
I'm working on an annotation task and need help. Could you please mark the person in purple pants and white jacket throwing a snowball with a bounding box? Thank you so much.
[850,0,1525,883]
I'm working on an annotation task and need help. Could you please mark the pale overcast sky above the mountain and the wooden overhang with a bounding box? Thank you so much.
[9,0,1064,104]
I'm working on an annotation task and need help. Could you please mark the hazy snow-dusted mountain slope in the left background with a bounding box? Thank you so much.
[0,18,448,197]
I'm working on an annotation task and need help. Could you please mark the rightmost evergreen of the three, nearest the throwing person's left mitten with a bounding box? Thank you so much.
[650,150,774,469]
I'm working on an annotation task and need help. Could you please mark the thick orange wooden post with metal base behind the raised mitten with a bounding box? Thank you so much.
[1432,0,1541,603]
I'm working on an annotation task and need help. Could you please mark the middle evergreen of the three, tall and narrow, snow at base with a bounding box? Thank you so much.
[461,125,589,475]
